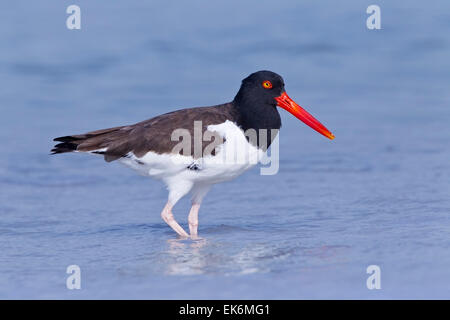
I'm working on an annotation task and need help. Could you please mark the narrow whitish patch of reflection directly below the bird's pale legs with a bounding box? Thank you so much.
[166,238,207,275]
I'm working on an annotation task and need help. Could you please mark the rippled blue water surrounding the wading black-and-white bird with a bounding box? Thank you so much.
[0,0,450,299]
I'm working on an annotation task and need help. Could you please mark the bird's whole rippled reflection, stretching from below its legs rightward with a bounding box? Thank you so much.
[162,230,350,275]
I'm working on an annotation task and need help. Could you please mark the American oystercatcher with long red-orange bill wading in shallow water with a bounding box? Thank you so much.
[51,71,334,238]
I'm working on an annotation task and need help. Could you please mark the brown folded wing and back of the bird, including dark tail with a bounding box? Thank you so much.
[52,103,237,162]
